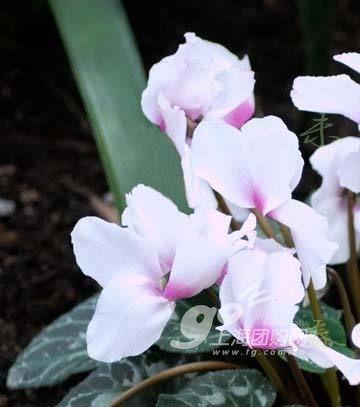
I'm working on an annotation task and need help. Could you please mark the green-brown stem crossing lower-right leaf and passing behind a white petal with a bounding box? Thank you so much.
[307,279,341,407]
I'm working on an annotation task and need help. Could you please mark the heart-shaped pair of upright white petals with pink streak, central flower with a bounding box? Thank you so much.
[191,116,303,213]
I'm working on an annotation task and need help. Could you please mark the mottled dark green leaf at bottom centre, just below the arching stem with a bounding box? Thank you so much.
[156,369,276,407]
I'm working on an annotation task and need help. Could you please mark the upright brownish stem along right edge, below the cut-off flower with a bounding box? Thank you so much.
[347,191,360,320]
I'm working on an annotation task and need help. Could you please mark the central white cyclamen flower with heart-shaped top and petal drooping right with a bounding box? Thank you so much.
[191,116,337,289]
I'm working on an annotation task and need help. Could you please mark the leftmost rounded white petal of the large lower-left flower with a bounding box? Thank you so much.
[71,216,162,286]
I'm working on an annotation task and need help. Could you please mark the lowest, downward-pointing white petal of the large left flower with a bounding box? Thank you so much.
[86,275,174,363]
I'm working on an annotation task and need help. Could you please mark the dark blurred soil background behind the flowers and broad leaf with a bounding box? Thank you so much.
[0,0,360,407]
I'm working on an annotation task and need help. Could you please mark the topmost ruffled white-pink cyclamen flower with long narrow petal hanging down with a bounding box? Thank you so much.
[141,33,255,208]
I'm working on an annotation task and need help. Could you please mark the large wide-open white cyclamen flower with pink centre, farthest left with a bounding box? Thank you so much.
[72,185,256,362]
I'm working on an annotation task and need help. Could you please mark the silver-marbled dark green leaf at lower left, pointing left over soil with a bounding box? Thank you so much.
[7,295,98,389]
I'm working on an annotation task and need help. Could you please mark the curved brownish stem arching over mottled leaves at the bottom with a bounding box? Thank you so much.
[109,360,240,407]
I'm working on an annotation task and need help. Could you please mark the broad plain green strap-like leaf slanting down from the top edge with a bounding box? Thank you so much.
[50,0,187,214]
